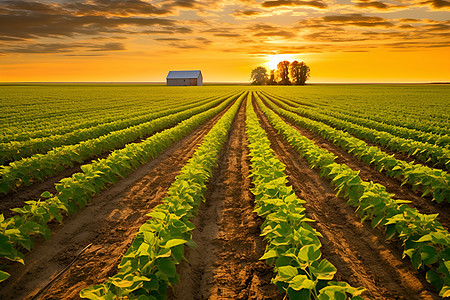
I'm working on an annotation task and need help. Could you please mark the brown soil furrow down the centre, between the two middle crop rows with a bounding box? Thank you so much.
[168,98,282,299]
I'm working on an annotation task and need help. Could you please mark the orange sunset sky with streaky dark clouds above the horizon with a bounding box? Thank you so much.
[0,0,450,83]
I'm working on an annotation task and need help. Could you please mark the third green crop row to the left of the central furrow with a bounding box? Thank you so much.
[0,98,232,194]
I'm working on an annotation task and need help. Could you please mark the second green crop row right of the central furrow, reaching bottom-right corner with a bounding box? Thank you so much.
[257,94,450,297]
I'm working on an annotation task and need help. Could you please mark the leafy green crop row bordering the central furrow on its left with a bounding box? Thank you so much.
[80,90,246,299]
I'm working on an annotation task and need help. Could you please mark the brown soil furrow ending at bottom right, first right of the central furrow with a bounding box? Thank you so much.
[253,97,440,299]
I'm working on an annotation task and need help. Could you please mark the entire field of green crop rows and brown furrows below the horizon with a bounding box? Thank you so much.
[0,84,450,300]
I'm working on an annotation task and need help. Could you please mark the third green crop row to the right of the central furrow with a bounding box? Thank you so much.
[262,95,450,203]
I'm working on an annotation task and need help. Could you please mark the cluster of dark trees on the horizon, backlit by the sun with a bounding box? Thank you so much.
[250,60,310,85]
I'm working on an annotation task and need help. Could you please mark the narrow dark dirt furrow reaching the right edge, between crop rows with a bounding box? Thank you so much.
[268,99,450,230]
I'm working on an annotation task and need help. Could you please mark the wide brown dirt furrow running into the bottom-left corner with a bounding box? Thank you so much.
[0,106,229,299]
